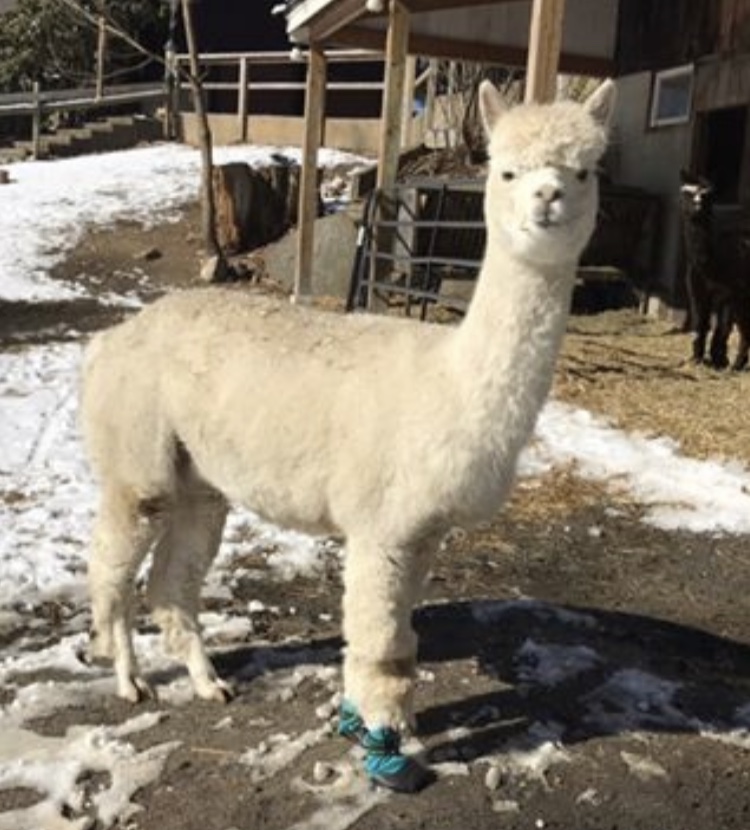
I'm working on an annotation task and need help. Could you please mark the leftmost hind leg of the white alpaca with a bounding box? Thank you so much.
[88,488,161,703]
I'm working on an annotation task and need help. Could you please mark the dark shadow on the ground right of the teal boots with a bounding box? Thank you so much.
[415,600,750,758]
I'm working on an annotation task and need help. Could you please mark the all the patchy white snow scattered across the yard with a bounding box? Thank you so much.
[0,144,750,830]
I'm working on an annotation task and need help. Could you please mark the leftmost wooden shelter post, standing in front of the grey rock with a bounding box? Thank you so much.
[292,44,327,303]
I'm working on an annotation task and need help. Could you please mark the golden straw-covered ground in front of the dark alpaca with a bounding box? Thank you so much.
[553,310,750,465]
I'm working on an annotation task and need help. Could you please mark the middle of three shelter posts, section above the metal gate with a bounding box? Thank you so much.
[377,0,409,189]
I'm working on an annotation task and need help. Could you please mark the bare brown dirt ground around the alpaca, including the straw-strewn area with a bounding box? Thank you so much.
[0,203,750,830]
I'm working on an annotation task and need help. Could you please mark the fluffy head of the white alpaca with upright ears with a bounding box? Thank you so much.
[479,81,615,265]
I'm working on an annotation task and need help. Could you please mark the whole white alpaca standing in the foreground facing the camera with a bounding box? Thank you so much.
[82,82,614,788]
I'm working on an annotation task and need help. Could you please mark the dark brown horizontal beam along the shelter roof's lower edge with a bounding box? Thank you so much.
[332,26,615,78]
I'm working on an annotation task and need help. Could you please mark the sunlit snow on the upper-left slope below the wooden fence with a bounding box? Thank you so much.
[0,144,368,301]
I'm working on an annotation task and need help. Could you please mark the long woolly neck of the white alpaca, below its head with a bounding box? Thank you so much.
[455,243,576,449]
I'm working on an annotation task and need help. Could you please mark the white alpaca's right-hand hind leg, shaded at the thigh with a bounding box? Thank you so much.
[148,484,232,702]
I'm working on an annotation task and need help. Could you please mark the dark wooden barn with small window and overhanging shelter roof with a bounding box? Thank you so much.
[274,0,750,308]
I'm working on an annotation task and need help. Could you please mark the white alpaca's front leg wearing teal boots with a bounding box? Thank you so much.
[339,541,432,792]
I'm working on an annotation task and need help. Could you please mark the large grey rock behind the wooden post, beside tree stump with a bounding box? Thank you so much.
[263,213,357,299]
